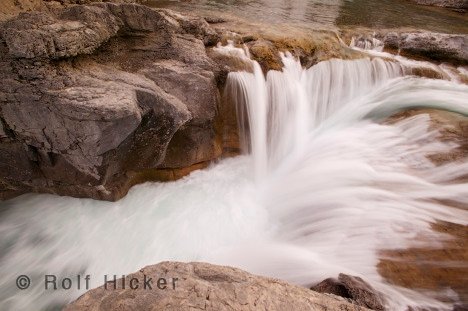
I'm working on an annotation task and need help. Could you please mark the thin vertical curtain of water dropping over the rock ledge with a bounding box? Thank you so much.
[222,43,403,178]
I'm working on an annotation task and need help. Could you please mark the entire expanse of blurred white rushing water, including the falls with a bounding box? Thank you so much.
[0,42,468,310]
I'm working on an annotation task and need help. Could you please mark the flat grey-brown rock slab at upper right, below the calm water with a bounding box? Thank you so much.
[382,32,468,65]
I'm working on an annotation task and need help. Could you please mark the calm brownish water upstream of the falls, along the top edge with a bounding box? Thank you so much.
[147,0,468,33]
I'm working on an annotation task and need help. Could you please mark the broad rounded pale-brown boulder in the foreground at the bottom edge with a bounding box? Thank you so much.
[64,262,367,311]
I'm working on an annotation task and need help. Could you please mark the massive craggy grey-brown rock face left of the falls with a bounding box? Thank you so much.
[0,3,225,200]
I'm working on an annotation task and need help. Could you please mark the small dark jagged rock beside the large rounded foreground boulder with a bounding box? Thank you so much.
[311,273,385,310]
